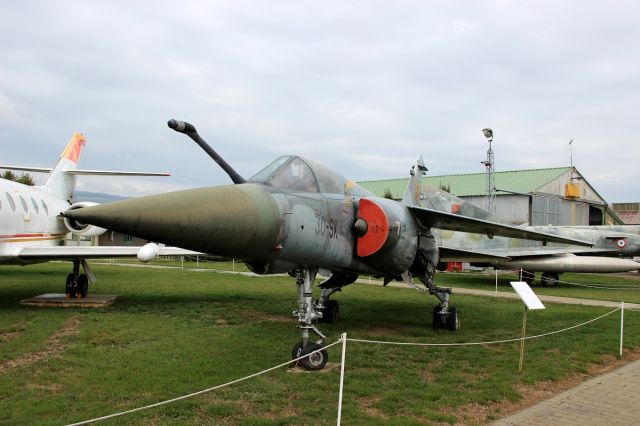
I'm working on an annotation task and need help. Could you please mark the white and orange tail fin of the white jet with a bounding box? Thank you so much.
[43,133,87,200]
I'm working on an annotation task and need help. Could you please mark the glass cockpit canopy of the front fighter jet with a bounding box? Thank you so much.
[249,155,369,196]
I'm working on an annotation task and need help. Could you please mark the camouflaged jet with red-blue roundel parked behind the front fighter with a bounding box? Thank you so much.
[421,188,640,287]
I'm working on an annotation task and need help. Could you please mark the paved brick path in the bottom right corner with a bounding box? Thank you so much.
[492,361,640,426]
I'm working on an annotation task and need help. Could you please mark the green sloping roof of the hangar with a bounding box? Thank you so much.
[358,167,571,199]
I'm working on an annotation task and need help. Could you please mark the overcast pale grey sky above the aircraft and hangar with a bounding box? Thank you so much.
[0,0,640,202]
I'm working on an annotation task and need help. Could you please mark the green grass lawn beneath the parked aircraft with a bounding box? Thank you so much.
[0,263,640,425]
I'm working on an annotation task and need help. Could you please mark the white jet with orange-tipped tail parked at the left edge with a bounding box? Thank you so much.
[0,133,199,298]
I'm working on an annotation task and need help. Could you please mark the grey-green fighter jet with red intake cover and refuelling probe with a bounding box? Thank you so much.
[62,120,589,370]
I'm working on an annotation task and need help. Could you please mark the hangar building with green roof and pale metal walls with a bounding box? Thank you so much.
[358,167,622,225]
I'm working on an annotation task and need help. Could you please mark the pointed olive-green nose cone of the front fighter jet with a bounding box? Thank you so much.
[64,184,280,260]
